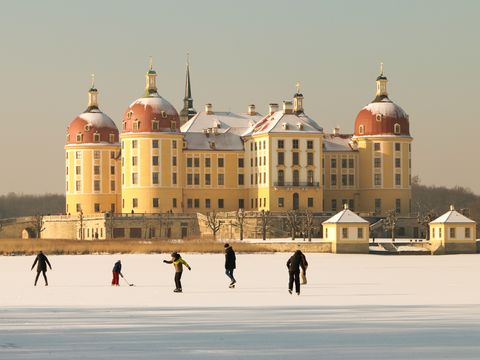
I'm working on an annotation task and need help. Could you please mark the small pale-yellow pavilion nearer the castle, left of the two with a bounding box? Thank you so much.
[322,204,370,254]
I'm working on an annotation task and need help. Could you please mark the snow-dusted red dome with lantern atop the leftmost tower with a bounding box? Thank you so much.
[67,81,119,144]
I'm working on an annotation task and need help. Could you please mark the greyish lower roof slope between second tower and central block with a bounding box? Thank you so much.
[183,132,243,151]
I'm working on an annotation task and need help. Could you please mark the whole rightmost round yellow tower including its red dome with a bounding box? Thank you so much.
[352,64,412,215]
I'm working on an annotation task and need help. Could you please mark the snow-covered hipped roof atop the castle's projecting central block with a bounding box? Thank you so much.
[243,110,323,135]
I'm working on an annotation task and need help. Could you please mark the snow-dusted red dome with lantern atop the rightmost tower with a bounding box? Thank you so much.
[355,64,410,136]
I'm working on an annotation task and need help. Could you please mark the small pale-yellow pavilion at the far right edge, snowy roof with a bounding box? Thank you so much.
[429,205,477,255]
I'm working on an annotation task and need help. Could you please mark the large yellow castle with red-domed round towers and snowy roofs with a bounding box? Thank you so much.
[65,64,412,216]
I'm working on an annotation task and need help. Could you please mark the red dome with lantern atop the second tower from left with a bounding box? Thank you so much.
[123,64,180,132]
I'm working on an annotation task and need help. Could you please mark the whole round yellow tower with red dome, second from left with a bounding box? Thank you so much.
[120,63,183,213]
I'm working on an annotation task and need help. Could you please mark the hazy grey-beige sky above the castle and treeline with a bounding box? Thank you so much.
[0,0,480,194]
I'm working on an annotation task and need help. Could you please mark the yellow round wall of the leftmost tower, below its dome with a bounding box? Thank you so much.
[65,144,121,214]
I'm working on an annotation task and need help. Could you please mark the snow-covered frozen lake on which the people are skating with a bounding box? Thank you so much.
[0,254,480,359]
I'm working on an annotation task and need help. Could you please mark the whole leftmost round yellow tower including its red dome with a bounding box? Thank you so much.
[65,77,120,221]
